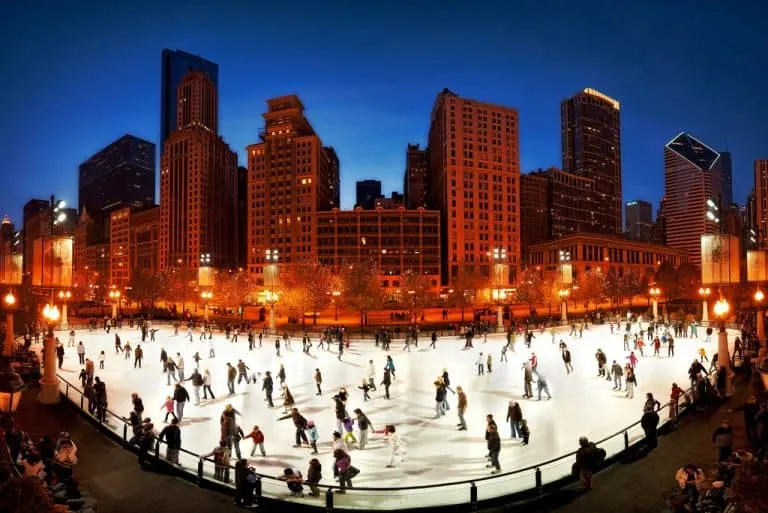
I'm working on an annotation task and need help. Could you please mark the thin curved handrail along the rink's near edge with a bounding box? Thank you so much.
[59,352,716,492]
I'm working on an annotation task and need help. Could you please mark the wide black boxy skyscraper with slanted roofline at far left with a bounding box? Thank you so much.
[78,135,155,217]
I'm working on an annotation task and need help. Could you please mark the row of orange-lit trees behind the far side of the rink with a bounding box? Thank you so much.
[72,260,698,324]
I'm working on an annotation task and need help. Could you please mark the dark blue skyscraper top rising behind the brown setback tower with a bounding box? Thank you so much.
[160,49,219,149]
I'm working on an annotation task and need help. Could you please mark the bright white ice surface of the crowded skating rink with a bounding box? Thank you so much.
[48,325,735,509]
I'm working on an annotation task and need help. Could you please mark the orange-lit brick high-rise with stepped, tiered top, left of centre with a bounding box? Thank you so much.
[247,95,339,283]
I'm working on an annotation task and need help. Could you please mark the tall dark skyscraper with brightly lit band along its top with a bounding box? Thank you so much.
[560,88,622,234]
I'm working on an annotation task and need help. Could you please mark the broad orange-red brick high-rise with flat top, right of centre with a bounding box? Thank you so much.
[428,89,520,285]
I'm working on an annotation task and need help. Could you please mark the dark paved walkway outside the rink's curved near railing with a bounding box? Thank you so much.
[10,372,752,513]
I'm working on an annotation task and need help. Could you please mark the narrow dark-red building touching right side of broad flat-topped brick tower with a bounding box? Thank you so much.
[520,174,549,261]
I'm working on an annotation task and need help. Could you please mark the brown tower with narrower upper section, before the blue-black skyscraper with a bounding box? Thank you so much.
[159,71,237,270]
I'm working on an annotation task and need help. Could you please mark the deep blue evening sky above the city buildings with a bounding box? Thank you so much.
[0,0,768,221]
